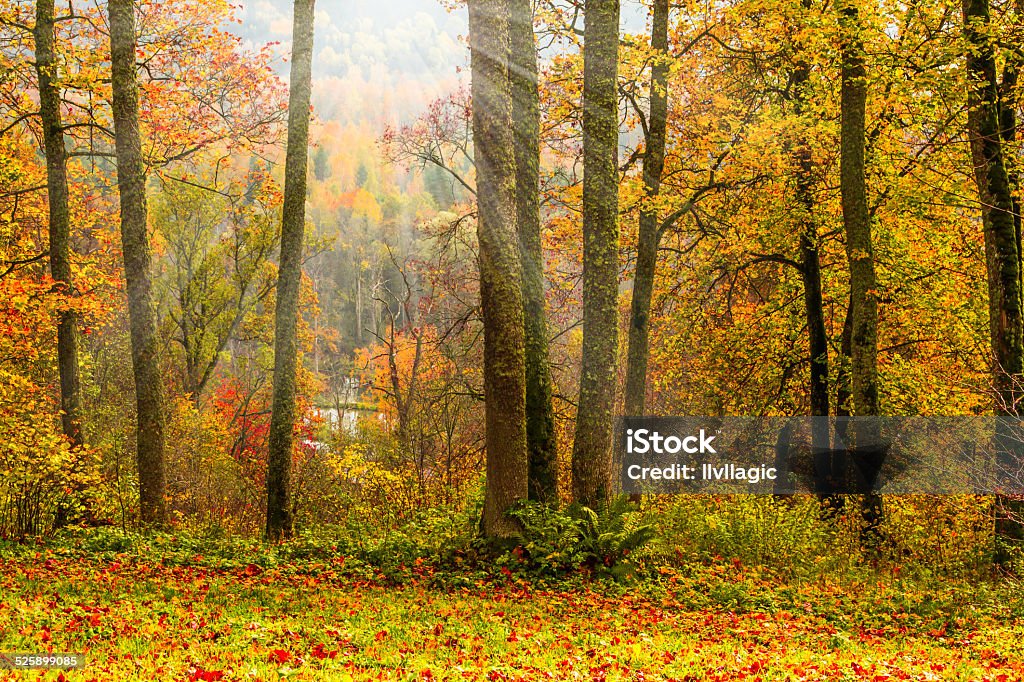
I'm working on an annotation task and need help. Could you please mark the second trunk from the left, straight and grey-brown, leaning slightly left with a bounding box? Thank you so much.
[108,0,167,525]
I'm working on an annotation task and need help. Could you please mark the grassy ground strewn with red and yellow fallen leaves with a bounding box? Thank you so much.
[0,548,1024,682]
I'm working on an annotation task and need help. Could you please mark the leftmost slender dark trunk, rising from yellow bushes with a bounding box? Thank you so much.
[35,0,84,447]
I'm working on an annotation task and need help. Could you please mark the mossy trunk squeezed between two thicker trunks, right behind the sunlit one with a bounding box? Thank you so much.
[509,0,558,502]
